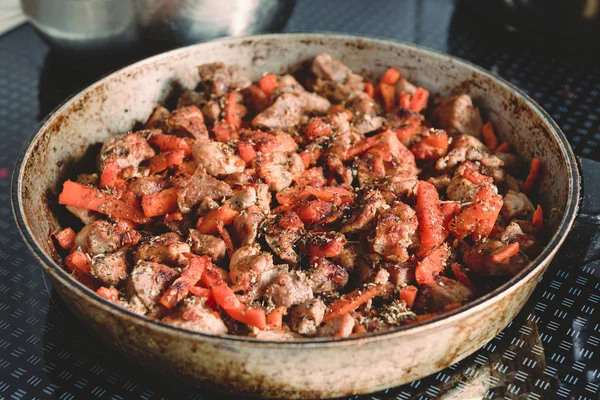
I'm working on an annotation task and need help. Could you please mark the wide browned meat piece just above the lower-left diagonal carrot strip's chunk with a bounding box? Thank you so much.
[134,232,192,265]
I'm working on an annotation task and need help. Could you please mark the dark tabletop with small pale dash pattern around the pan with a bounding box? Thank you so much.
[0,0,600,400]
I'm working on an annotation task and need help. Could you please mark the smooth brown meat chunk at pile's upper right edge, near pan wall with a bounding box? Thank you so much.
[437,94,483,137]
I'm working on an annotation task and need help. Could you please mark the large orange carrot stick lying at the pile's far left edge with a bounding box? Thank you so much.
[58,181,149,224]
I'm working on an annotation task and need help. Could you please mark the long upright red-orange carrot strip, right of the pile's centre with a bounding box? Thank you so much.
[416,181,445,257]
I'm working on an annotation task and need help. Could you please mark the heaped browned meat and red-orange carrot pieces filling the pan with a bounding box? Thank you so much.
[52,54,543,340]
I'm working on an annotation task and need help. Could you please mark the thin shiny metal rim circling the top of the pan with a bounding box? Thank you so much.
[11,33,581,348]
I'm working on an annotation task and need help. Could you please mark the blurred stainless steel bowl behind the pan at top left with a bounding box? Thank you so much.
[21,0,295,57]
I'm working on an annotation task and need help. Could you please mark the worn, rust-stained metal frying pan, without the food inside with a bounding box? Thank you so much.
[12,34,596,398]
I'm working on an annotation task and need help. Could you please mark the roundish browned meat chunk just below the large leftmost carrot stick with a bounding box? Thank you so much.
[75,220,121,257]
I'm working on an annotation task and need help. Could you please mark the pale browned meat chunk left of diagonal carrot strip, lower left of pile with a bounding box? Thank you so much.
[131,261,179,308]
